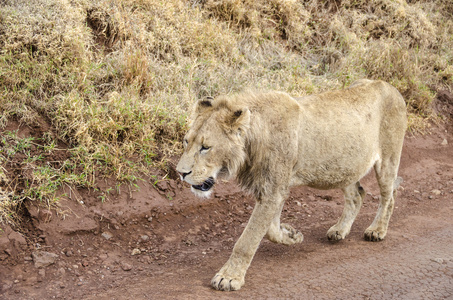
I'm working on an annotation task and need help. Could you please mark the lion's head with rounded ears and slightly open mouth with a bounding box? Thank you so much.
[176,97,250,197]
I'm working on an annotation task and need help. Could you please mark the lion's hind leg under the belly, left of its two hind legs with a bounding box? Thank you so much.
[327,182,365,241]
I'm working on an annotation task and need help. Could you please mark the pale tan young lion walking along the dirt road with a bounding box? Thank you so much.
[177,79,407,291]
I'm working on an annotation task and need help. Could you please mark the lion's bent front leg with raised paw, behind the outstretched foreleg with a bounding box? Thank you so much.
[266,203,304,245]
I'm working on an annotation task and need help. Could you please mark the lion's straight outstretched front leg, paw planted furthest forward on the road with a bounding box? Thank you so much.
[211,196,283,291]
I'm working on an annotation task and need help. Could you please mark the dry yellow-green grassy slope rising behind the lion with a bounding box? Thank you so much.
[0,0,453,222]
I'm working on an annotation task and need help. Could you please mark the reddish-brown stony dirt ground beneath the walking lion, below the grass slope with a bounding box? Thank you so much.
[0,95,453,299]
